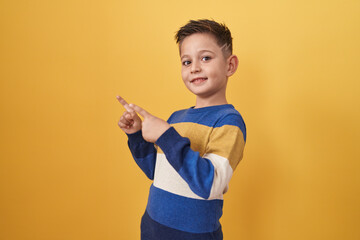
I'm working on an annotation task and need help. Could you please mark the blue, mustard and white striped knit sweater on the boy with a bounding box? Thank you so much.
[128,104,246,240]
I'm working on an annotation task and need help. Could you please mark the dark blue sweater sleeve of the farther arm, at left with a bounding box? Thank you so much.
[127,130,157,180]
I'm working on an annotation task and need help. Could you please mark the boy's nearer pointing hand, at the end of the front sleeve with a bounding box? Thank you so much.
[129,104,171,143]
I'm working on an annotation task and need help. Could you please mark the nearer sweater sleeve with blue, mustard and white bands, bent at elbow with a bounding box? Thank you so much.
[156,115,245,199]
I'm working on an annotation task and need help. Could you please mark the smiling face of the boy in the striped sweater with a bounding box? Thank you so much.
[180,33,228,98]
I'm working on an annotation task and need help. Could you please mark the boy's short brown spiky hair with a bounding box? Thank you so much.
[175,19,232,55]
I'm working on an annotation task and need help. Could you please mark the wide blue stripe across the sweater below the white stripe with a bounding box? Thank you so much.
[146,185,223,233]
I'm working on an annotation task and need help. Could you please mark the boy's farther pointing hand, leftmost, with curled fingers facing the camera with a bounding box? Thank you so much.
[116,96,141,134]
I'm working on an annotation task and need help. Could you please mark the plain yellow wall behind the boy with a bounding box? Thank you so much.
[0,0,360,240]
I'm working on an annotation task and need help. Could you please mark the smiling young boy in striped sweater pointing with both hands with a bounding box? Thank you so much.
[117,20,246,240]
